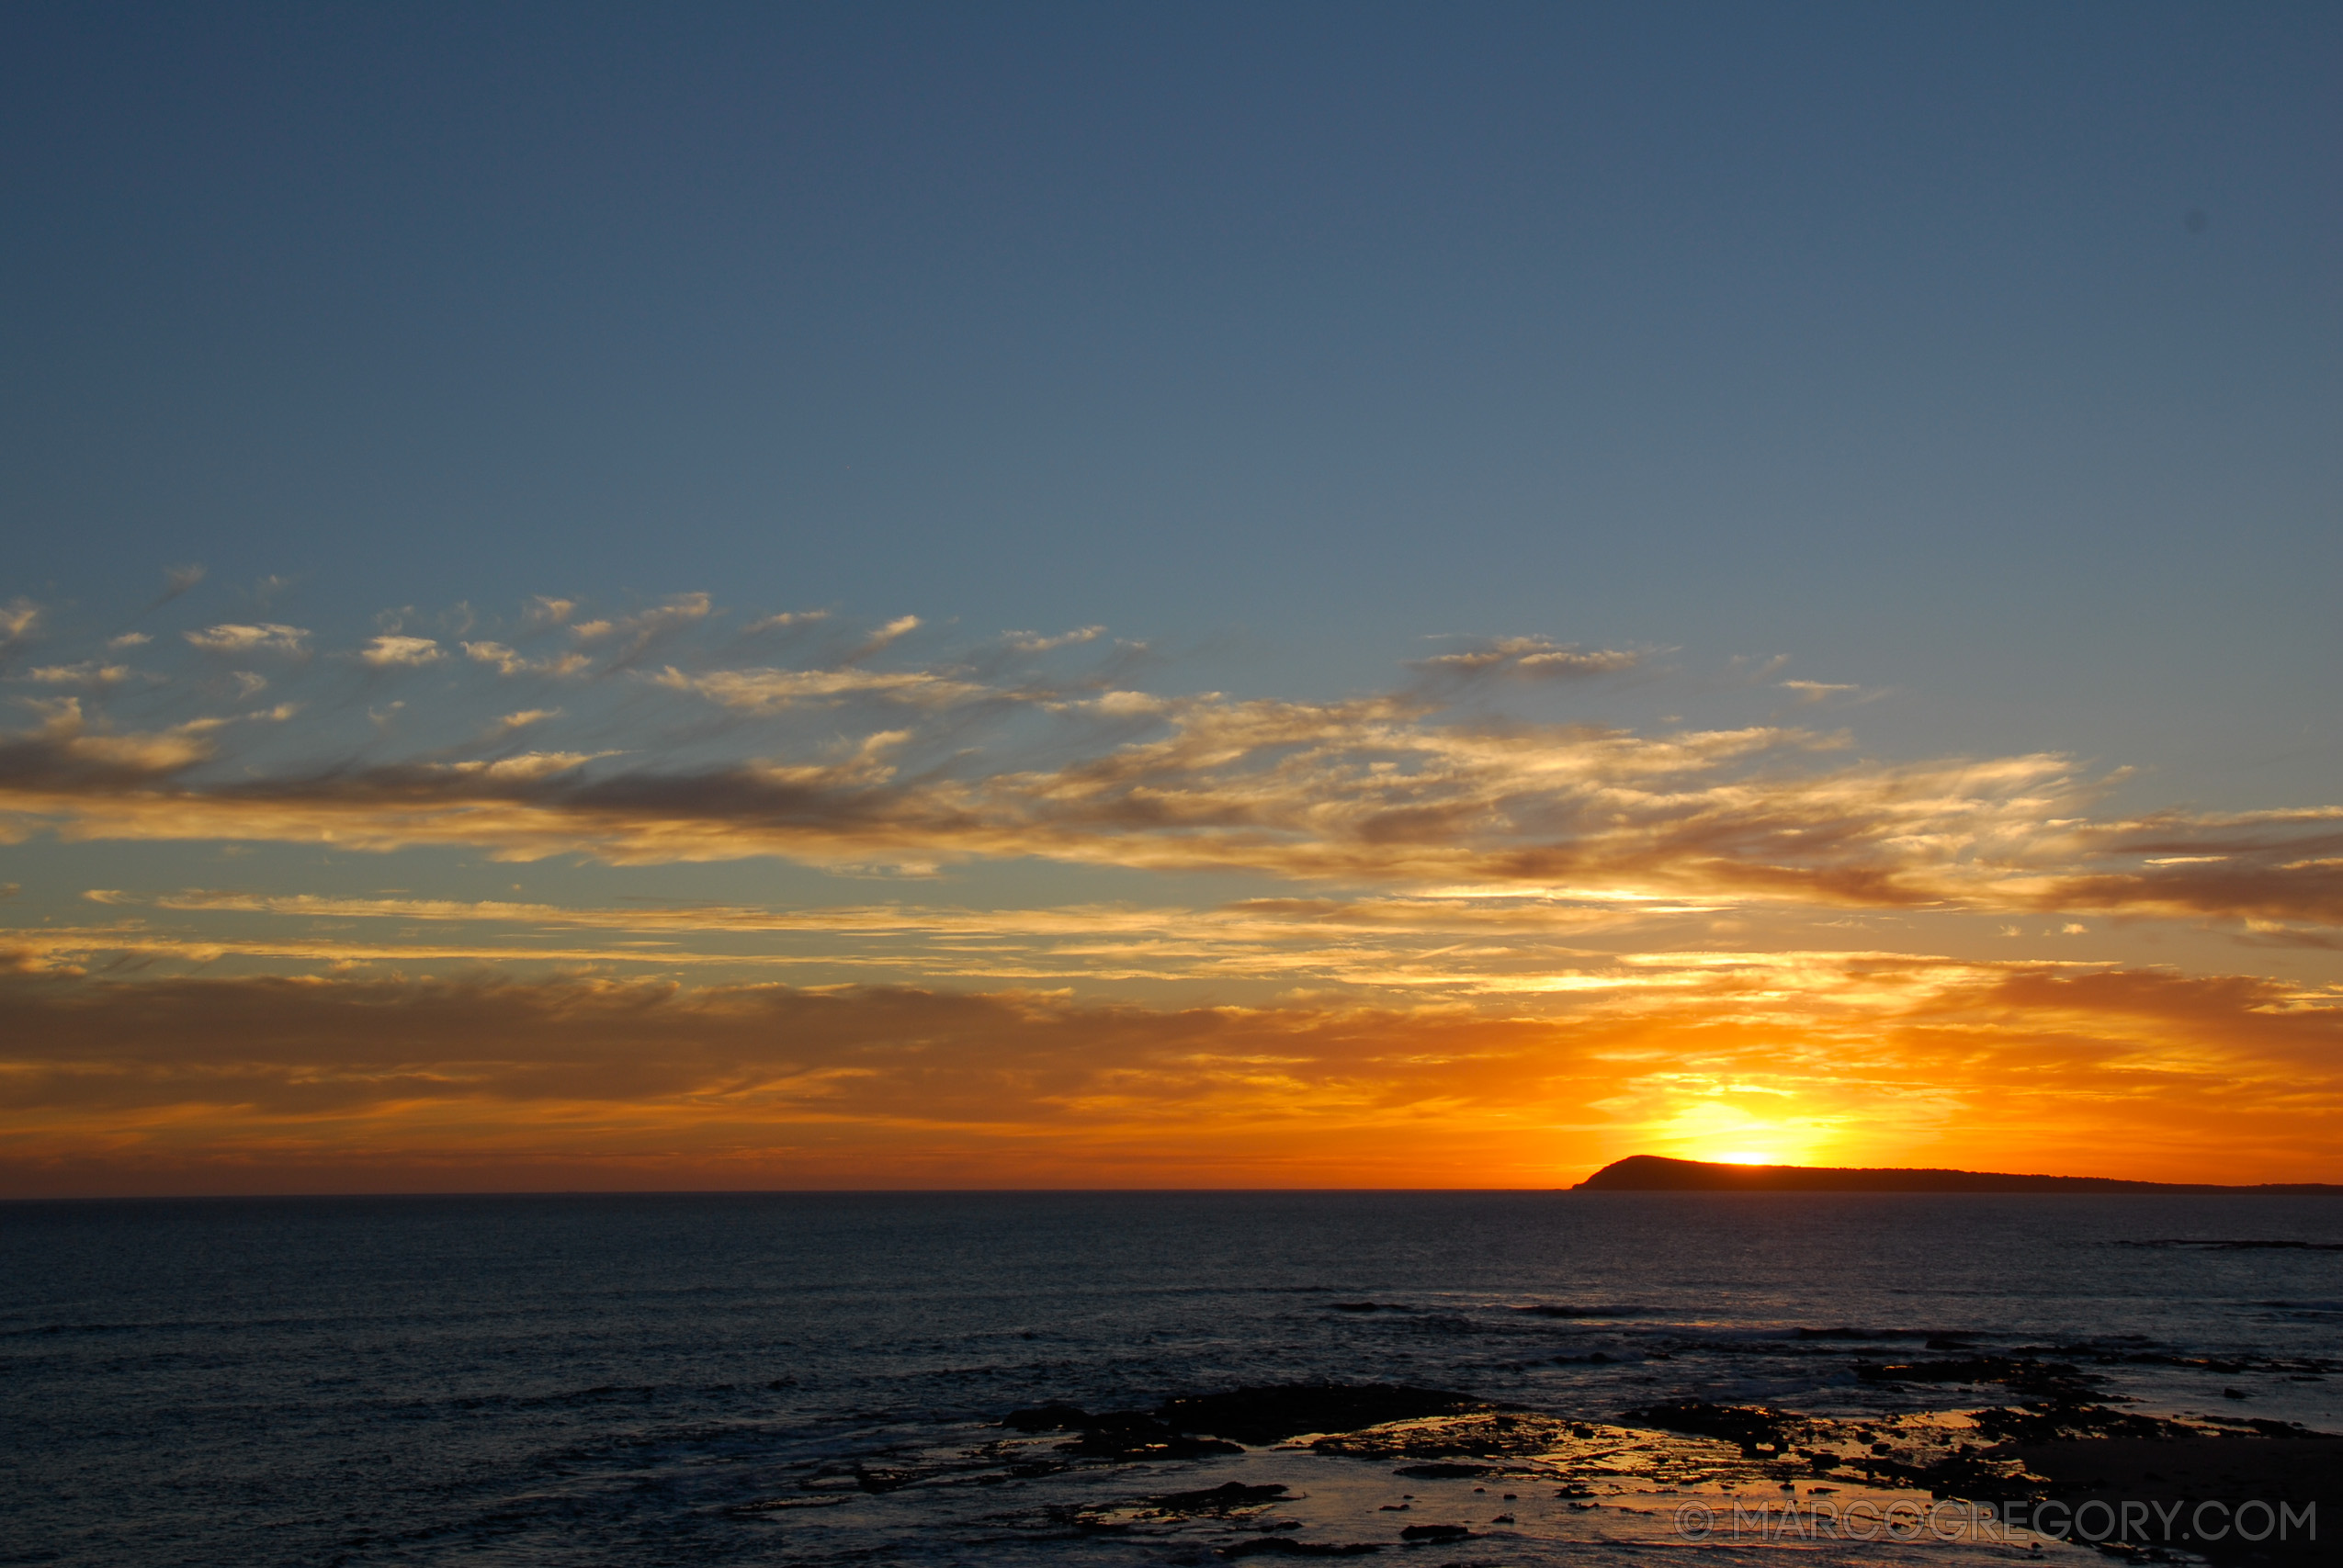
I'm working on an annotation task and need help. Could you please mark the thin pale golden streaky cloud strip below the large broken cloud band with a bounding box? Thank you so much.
[45,888,1687,998]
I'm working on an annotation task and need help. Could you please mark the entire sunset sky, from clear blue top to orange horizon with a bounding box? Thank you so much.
[0,3,2343,1195]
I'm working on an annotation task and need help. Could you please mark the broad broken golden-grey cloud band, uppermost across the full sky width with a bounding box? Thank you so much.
[0,595,2343,940]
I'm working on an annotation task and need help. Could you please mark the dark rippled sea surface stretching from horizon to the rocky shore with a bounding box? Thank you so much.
[0,1193,2343,1568]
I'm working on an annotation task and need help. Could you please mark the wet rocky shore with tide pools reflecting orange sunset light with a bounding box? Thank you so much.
[738,1357,2343,1568]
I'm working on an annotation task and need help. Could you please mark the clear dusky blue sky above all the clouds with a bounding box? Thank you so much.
[5,5,2343,773]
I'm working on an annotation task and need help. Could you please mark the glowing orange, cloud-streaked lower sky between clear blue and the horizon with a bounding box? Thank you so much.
[0,595,2343,1195]
